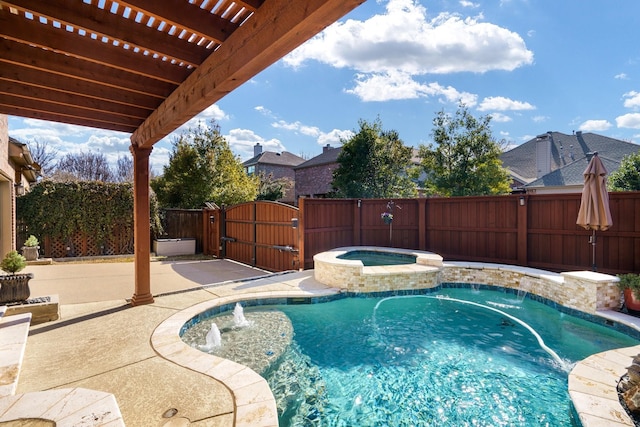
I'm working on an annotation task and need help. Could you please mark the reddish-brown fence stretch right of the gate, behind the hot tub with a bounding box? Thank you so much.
[299,192,640,274]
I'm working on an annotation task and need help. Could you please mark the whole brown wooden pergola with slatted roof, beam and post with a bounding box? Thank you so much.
[0,0,365,305]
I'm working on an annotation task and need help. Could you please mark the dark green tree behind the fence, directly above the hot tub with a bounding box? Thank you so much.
[332,119,416,198]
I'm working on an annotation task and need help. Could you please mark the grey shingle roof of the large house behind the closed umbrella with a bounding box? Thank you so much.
[500,132,640,185]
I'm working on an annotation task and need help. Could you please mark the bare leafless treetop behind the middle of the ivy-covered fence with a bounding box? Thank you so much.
[52,151,114,182]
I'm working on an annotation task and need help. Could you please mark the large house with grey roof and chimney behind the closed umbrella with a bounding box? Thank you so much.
[500,131,640,194]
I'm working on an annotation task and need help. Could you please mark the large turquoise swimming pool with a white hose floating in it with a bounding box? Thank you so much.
[182,288,638,426]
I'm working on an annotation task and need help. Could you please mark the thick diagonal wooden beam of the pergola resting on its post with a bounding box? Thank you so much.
[131,0,364,147]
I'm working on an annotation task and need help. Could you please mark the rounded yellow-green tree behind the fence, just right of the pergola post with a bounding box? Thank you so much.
[151,122,258,209]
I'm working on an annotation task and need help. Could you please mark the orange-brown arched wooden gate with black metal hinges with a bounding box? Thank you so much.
[221,201,300,271]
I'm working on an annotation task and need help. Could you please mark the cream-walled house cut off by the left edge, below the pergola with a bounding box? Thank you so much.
[0,114,40,258]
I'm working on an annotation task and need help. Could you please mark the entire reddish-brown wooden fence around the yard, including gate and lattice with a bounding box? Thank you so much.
[17,192,640,274]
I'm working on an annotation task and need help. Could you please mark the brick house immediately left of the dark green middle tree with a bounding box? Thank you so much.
[294,144,342,200]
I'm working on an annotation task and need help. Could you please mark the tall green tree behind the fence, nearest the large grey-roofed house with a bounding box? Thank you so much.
[420,104,510,196]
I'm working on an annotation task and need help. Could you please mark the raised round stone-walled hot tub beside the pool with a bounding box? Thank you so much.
[313,246,442,292]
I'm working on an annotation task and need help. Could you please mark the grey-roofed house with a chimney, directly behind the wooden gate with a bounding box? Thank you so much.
[242,144,304,203]
